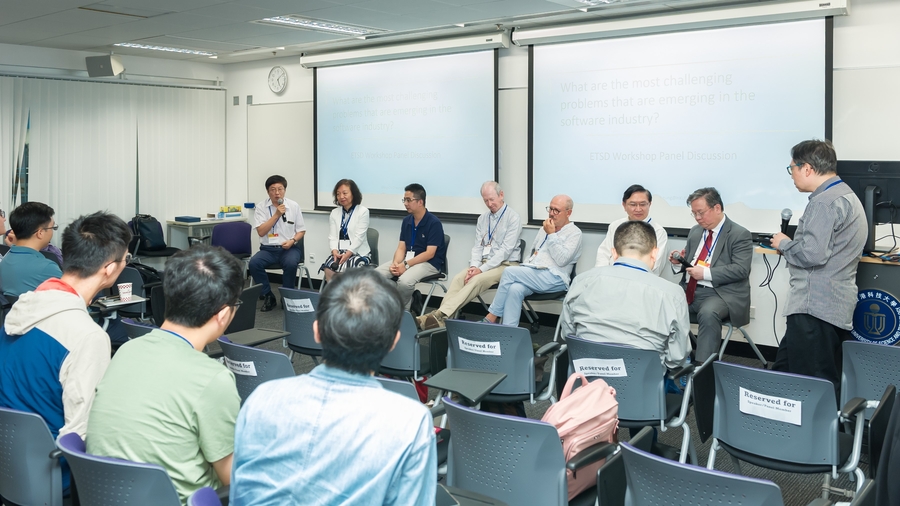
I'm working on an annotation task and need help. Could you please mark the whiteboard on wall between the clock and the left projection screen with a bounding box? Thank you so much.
[247,102,314,210]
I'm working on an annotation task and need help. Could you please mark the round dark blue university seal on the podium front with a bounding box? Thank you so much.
[850,289,900,346]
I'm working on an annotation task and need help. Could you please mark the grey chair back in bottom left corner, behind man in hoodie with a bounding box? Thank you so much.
[0,408,63,506]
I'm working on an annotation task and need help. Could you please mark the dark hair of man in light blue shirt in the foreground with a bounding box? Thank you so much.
[316,269,403,374]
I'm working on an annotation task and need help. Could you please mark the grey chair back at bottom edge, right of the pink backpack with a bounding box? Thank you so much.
[621,443,784,506]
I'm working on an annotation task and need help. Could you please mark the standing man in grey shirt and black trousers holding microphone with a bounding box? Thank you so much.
[772,140,867,398]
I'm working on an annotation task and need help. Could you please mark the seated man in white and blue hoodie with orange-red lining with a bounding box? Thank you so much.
[0,213,131,486]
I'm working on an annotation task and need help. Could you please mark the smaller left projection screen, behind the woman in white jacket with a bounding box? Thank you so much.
[315,50,497,215]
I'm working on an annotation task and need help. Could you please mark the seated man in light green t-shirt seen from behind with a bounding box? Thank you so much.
[87,245,243,501]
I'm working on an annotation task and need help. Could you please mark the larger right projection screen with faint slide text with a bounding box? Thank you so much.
[530,19,840,233]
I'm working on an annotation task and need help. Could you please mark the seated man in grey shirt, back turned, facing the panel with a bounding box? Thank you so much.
[560,221,691,369]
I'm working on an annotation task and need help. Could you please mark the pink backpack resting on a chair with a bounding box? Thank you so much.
[541,373,619,500]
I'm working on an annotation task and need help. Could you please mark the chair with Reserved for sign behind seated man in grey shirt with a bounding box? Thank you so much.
[566,336,697,464]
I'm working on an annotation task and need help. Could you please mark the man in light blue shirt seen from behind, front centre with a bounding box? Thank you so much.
[230,269,437,506]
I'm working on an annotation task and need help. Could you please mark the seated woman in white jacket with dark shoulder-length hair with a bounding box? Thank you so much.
[319,179,377,281]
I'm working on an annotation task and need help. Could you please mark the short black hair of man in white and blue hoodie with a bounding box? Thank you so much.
[62,212,131,279]
